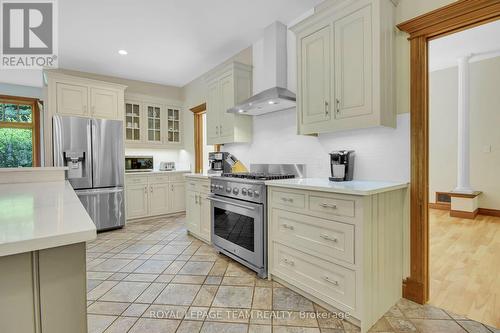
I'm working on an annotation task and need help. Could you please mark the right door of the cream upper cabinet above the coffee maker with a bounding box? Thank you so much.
[335,7,373,119]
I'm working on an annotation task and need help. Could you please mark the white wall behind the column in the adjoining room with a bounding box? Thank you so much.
[429,54,500,209]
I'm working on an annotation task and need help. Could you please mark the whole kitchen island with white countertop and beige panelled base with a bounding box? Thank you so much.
[0,168,96,333]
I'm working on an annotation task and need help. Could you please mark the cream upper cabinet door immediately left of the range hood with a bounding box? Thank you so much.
[219,73,236,139]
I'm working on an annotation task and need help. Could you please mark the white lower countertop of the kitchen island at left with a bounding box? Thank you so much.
[0,181,96,256]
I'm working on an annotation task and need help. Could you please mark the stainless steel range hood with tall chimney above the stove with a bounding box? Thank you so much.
[227,22,295,116]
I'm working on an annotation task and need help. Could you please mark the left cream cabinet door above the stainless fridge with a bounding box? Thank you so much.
[56,83,88,116]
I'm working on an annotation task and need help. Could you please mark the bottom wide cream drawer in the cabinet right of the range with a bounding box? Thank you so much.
[272,242,356,311]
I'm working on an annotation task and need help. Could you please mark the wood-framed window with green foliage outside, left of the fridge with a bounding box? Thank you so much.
[0,95,40,168]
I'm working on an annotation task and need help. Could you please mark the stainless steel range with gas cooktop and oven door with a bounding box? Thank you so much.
[209,164,304,278]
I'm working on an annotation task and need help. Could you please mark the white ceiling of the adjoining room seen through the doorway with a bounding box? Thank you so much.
[429,21,500,72]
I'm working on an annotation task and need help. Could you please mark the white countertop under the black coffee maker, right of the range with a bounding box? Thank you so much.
[266,178,408,195]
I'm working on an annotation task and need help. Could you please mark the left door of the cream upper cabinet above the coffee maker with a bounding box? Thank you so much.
[300,25,332,124]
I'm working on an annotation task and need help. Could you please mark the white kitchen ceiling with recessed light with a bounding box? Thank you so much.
[49,0,322,86]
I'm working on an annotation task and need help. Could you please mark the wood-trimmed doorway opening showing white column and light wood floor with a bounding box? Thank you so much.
[428,21,500,327]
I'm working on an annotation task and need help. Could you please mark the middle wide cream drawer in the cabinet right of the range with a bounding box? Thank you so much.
[271,209,354,264]
